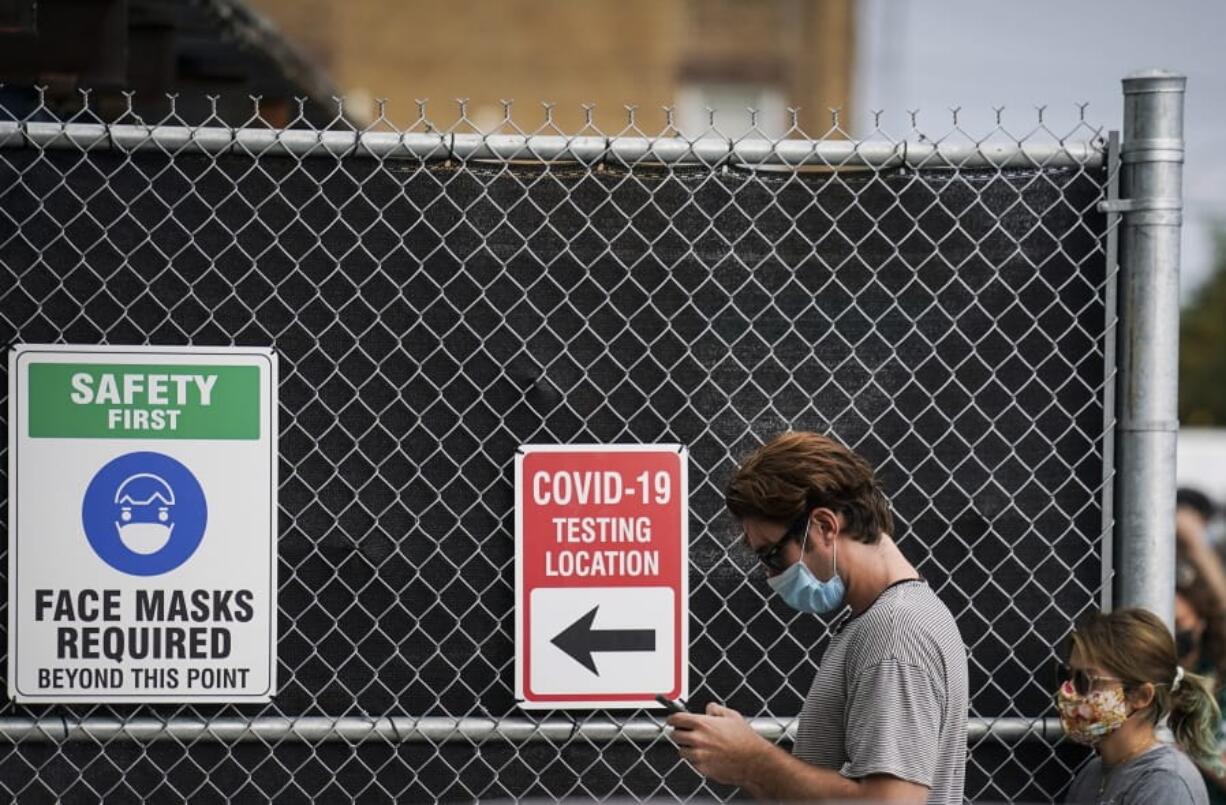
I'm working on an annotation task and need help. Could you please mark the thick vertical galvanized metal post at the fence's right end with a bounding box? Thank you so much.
[1116,70,1187,624]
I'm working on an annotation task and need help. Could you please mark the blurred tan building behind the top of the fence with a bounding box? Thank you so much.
[241,0,855,136]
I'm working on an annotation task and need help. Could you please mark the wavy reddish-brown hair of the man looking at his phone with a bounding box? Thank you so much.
[725,431,894,544]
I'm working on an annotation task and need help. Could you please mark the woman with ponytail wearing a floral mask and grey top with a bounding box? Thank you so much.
[1056,609,1221,805]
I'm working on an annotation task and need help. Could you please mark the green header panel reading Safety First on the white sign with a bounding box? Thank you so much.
[29,363,260,439]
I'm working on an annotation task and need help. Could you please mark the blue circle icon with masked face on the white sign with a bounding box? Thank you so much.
[81,452,208,576]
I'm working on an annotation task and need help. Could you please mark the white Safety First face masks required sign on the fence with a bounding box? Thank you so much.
[9,346,277,702]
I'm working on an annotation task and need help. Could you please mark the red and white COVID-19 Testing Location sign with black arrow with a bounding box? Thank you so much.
[515,445,689,709]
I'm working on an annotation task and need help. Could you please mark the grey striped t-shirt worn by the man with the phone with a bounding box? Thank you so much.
[793,580,966,805]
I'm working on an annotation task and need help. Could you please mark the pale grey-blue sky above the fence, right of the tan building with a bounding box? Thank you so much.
[855,0,1226,300]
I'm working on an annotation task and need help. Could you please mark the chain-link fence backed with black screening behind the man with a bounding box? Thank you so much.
[0,91,1113,801]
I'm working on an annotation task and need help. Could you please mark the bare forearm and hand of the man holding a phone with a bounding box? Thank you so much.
[668,703,928,803]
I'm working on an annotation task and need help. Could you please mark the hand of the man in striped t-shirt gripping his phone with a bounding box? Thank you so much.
[668,702,771,785]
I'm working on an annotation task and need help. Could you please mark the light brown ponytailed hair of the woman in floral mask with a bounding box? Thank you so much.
[1069,609,1221,763]
